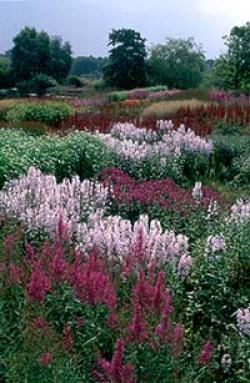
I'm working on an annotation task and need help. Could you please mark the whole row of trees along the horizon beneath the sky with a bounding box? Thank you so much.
[0,23,250,94]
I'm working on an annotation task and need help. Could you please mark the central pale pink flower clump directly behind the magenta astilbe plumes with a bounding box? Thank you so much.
[76,214,191,275]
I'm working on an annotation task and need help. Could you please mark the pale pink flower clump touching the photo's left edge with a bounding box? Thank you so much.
[0,167,109,235]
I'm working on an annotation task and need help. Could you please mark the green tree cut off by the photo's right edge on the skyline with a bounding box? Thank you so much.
[212,22,250,91]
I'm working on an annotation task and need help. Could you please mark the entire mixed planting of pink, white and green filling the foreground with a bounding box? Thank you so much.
[0,112,250,383]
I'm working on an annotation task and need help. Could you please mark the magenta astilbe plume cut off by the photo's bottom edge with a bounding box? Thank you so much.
[95,339,135,383]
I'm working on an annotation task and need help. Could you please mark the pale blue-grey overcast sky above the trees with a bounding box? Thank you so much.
[0,0,250,58]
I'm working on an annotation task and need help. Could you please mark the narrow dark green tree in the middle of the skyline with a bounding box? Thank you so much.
[104,29,147,89]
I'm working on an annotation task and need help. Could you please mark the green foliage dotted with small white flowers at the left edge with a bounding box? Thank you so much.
[0,129,114,186]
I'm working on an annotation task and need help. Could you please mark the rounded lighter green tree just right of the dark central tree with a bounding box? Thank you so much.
[149,38,205,89]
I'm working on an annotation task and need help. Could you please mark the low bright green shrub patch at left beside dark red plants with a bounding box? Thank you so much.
[6,101,72,125]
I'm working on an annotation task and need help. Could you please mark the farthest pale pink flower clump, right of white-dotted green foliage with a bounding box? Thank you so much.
[96,121,213,161]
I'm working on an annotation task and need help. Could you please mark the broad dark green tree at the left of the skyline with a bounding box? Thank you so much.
[11,27,72,81]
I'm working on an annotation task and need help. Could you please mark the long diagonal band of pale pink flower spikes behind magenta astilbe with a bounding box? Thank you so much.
[0,167,191,275]
